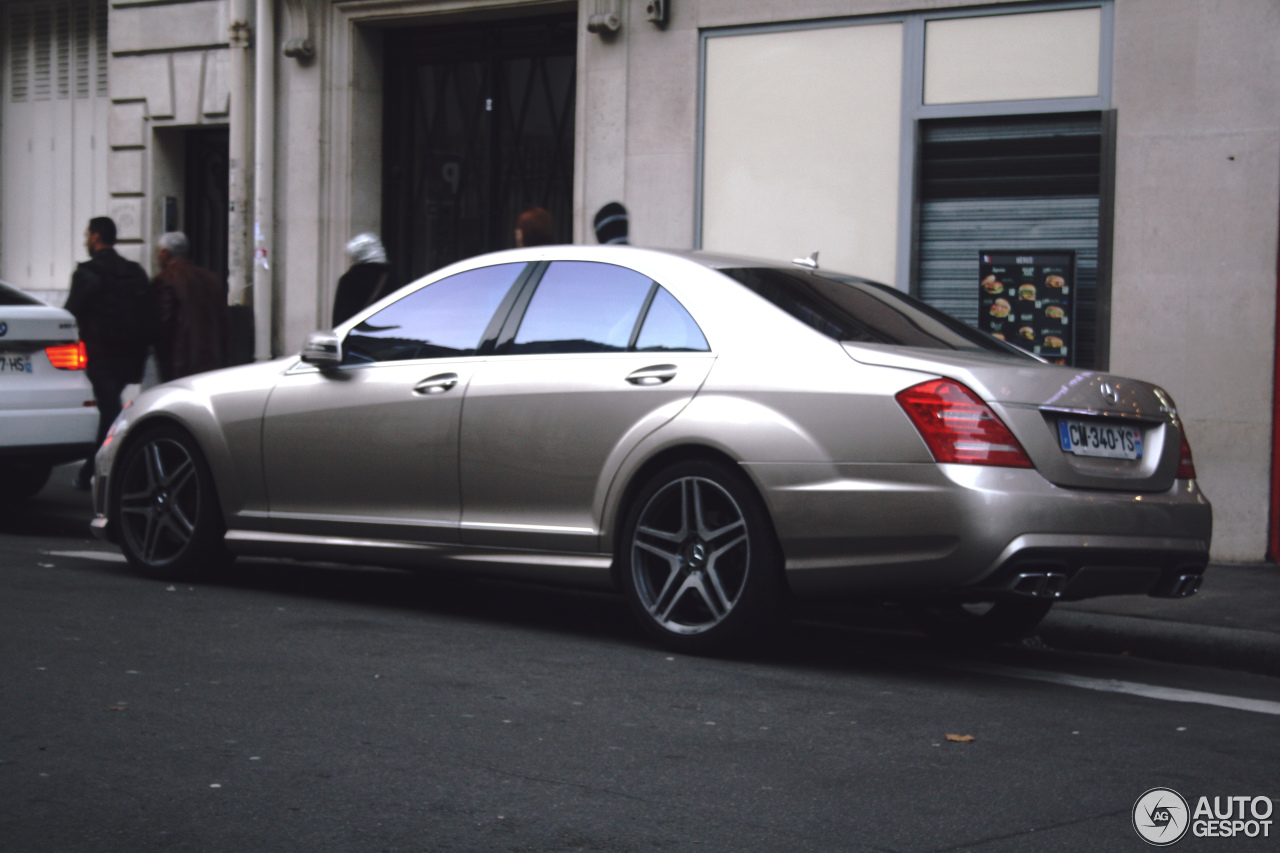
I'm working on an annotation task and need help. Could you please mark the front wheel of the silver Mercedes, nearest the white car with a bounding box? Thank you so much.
[111,424,232,580]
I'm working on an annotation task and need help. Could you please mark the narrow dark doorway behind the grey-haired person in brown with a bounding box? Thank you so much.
[182,128,230,282]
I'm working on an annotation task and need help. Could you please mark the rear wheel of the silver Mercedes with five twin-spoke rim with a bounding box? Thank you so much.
[620,461,785,654]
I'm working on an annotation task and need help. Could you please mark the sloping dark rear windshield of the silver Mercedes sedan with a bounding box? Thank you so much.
[719,266,1034,360]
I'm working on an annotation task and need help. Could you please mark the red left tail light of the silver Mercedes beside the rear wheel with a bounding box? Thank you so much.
[896,379,1034,467]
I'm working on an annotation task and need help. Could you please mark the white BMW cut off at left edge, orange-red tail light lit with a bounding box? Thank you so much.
[0,282,97,506]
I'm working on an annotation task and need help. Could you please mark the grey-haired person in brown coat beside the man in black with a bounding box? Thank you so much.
[152,231,229,382]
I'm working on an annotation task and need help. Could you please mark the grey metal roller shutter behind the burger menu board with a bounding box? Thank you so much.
[915,113,1102,368]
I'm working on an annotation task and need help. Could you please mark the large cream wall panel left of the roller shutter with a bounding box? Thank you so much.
[701,23,902,283]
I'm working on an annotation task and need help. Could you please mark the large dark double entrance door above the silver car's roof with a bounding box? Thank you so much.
[383,14,577,283]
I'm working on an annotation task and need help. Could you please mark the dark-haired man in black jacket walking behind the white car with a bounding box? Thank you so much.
[65,216,155,489]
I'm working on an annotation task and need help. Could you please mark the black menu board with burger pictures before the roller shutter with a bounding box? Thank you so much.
[978,248,1075,364]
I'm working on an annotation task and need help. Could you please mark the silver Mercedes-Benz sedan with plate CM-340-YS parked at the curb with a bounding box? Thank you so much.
[93,246,1212,652]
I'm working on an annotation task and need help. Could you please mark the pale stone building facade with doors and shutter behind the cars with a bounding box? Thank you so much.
[0,0,1280,561]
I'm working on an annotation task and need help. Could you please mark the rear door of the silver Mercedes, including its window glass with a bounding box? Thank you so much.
[460,261,714,551]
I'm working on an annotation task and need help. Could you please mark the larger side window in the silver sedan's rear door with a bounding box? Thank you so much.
[507,261,653,355]
